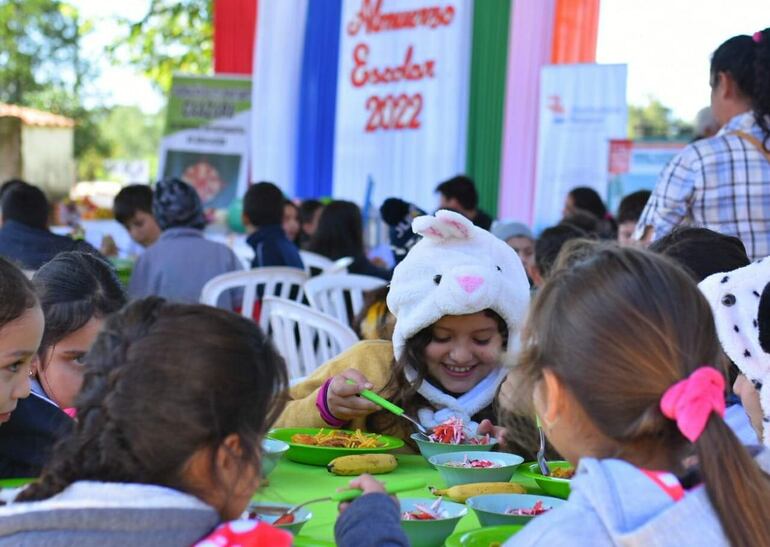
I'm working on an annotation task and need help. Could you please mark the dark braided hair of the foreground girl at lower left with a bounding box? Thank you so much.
[17,297,287,501]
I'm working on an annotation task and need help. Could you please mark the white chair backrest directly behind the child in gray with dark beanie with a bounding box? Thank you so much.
[201,267,307,326]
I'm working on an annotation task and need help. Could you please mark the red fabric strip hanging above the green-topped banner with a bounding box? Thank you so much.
[214,0,258,74]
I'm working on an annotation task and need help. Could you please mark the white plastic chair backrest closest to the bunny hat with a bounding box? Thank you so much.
[305,274,387,325]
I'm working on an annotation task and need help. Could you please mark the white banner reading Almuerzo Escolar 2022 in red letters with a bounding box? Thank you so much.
[333,0,473,210]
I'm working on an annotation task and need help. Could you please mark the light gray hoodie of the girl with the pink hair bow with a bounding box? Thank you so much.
[505,450,770,547]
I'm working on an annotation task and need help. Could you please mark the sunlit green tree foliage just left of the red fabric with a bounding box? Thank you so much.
[109,0,214,91]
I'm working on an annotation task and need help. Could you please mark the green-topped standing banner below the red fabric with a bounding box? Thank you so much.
[158,75,251,208]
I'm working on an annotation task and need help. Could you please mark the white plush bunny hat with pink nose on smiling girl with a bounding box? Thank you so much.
[388,211,530,359]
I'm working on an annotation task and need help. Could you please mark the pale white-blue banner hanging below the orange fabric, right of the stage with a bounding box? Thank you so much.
[534,64,628,231]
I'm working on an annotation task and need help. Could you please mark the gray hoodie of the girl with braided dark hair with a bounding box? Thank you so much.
[0,481,219,547]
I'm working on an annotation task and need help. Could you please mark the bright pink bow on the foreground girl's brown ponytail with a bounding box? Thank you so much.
[660,367,725,443]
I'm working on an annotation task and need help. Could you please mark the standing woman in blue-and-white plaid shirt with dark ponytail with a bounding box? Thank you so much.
[636,28,770,259]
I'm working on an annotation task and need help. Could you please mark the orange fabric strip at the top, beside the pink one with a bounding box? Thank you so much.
[551,0,599,65]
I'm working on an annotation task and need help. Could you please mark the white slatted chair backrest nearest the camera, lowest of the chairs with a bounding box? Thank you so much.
[262,296,358,380]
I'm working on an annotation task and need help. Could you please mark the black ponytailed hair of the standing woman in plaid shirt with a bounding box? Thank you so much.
[711,28,770,152]
